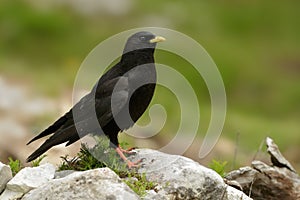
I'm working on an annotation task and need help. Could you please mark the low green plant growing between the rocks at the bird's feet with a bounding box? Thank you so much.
[59,137,156,196]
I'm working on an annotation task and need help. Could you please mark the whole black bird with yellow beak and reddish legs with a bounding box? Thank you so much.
[26,31,165,167]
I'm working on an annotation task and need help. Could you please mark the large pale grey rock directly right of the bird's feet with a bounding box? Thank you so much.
[131,149,251,200]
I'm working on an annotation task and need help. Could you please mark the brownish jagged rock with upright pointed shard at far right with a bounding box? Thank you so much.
[226,138,300,200]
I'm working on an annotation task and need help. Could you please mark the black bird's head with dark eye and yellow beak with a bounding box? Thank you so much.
[124,31,165,53]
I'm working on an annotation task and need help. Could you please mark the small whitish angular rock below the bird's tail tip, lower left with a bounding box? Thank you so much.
[0,163,55,200]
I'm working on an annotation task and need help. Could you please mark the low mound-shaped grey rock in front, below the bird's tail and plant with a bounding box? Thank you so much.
[22,168,140,200]
